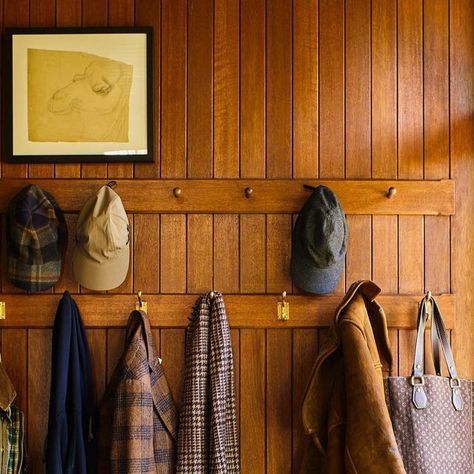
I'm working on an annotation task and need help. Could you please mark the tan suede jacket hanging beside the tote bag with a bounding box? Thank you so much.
[301,280,405,474]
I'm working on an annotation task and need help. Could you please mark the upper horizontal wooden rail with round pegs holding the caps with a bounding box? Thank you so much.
[0,179,455,215]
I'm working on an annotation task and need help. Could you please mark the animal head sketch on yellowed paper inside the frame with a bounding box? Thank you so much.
[28,49,133,142]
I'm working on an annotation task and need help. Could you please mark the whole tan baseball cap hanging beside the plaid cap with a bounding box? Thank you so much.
[73,186,130,291]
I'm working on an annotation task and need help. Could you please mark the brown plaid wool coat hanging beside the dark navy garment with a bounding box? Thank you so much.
[98,311,178,474]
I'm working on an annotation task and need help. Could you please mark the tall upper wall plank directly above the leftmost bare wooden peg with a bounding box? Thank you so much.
[161,0,187,178]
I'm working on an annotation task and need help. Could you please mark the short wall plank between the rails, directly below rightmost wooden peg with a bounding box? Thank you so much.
[372,216,398,294]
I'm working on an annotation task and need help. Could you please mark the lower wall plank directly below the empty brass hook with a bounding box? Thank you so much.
[266,329,292,472]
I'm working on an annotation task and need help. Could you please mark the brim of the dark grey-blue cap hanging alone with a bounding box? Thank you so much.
[291,250,345,295]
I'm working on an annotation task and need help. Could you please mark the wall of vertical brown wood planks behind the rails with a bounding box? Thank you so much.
[0,0,474,474]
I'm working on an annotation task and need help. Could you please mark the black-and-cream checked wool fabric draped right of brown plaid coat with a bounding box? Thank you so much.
[177,293,240,474]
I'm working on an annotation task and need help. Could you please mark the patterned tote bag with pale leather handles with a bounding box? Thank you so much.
[384,296,474,474]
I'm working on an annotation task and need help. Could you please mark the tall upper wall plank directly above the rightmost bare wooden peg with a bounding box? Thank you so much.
[372,0,398,178]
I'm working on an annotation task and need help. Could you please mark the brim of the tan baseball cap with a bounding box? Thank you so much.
[72,245,130,291]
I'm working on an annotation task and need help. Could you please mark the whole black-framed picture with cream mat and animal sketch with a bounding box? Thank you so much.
[3,28,153,163]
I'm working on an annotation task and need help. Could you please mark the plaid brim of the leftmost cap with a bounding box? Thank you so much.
[8,255,62,292]
